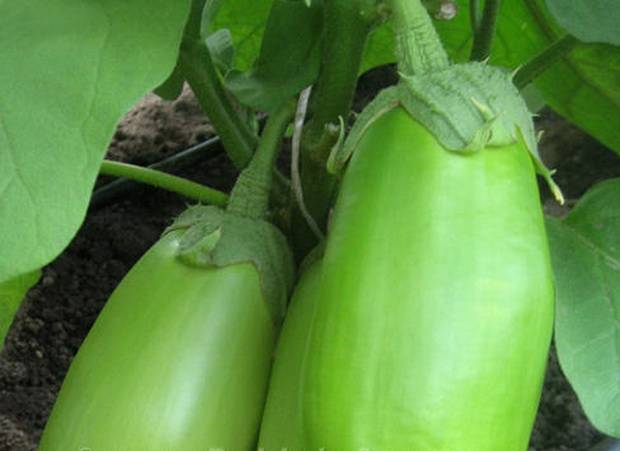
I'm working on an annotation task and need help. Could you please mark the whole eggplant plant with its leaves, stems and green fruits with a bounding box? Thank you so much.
[0,0,620,451]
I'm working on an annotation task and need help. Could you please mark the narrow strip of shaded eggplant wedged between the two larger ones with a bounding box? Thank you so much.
[258,262,321,451]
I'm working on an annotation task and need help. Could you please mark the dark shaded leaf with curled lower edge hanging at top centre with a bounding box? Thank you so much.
[225,0,323,112]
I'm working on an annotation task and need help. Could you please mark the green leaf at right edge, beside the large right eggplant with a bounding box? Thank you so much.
[547,179,620,437]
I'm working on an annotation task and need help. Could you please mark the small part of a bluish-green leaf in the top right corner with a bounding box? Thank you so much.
[546,0,620,45]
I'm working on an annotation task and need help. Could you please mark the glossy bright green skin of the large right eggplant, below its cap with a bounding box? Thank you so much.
[302,108,554,451]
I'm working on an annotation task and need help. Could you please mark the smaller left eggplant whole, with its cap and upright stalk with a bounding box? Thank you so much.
[39,102,295,451]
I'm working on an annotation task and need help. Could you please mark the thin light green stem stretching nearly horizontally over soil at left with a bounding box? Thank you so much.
[99,160,228,206]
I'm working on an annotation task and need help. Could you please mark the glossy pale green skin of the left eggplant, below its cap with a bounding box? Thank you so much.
[39,233,275,451]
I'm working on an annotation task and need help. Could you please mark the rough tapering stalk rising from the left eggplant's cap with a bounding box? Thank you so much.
[227,101,295,219]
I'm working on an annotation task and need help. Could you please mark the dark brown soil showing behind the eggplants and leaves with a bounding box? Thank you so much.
[0,73,620,451]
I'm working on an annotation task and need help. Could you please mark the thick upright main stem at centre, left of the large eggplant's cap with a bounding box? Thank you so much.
[292,0,380,256]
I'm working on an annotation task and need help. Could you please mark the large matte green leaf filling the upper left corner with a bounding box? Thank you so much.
[0,0,189,282]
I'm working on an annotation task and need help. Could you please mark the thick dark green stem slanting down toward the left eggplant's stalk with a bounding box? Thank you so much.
[179,38,256,169]
